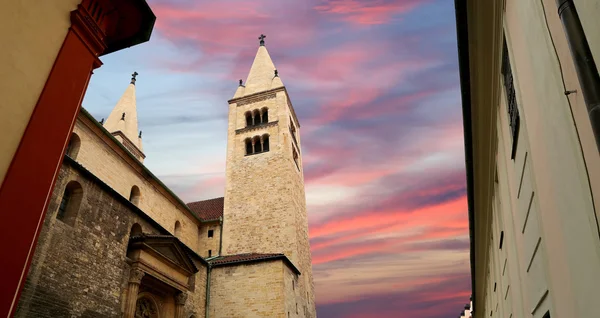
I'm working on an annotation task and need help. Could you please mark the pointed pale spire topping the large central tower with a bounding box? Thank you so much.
[234,34,283,98]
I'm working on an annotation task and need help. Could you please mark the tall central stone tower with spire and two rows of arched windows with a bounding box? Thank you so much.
[222,35,316,317]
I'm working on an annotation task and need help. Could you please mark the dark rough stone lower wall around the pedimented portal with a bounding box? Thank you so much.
[15,159,206,318]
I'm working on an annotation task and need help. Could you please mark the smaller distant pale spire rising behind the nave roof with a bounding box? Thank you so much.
[104,72,146,162]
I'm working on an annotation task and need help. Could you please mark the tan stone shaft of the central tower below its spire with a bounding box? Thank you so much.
[223,90,316,317]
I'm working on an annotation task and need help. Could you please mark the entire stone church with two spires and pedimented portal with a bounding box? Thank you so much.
[15,36,316,318]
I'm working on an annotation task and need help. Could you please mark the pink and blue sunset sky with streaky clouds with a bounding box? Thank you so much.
[83,0,470,318]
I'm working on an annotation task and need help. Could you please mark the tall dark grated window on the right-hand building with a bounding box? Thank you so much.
[502,37,520,159]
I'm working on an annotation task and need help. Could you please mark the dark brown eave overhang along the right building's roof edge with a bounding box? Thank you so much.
[454,0,504,310]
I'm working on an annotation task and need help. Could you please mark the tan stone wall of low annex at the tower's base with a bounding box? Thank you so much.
[209,260,287,318]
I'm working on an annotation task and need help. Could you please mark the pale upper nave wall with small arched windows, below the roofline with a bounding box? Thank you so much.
[73,114,201,252]
